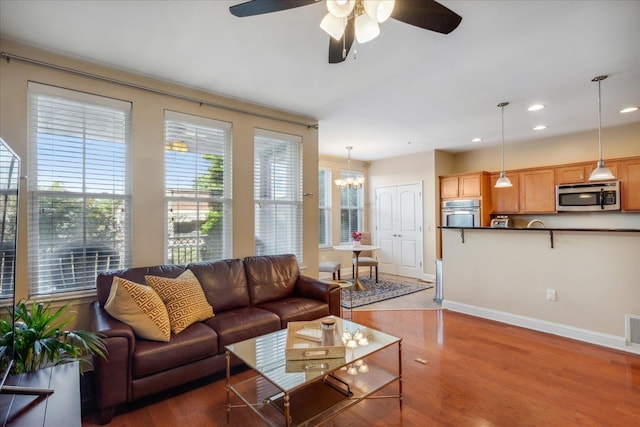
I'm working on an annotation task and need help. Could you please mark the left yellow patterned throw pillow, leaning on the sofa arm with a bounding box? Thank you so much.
[104,277,171,342]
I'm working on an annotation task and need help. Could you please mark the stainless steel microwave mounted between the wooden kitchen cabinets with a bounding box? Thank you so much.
[556,181,620,212]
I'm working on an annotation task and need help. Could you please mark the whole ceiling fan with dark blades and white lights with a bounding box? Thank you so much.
[229,0,462,64]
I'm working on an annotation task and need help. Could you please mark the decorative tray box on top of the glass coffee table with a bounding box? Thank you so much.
[285,316,345,360]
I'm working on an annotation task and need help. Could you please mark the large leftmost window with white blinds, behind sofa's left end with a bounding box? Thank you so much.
[28,83,131,296]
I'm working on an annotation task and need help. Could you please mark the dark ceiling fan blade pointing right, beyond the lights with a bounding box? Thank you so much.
[391,0,462,34]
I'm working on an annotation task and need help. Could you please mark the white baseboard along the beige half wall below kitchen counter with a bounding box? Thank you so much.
[442,300,640,354]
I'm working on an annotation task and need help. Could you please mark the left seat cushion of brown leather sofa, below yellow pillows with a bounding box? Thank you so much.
[131,323,218,378]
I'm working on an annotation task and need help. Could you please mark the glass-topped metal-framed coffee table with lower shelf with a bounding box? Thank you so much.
[225,317,402,427]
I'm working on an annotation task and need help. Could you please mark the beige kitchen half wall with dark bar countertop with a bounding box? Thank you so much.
[441,227,640,353]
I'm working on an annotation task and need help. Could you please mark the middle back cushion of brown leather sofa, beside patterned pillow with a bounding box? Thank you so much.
[187,259,249,314]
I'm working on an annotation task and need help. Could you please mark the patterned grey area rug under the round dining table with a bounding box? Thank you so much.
[342,278,433,308]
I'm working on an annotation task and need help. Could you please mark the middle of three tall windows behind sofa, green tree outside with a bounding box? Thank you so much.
[165,111,233,264]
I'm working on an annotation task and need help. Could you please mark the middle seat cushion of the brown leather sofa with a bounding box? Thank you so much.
[205,307,280,353]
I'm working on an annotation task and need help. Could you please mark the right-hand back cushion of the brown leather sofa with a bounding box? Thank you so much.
[244,255,300,305]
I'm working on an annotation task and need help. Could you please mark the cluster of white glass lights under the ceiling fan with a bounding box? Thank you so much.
[320,0,395,43]
